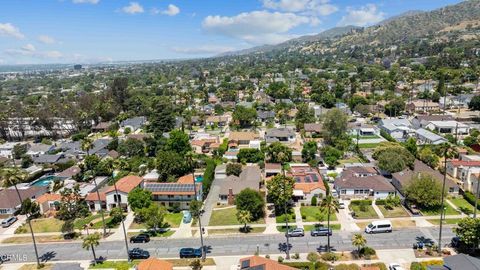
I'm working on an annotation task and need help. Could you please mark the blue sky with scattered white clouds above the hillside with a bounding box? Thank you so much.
[0,0,460,64]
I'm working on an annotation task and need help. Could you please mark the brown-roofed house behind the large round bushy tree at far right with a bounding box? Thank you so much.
[392,159,459,195]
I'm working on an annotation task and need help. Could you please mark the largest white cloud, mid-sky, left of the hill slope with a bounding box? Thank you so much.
[202,11,316,44]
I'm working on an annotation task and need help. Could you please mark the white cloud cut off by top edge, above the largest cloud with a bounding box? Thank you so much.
[262,0,338,16]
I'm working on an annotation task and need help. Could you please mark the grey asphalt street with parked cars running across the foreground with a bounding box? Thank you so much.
[0,228,454,263]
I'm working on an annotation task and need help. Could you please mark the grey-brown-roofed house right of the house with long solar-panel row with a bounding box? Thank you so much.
[216,165,262,205]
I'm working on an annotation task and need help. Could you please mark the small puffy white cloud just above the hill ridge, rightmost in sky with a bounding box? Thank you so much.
[338,4,385,26]
